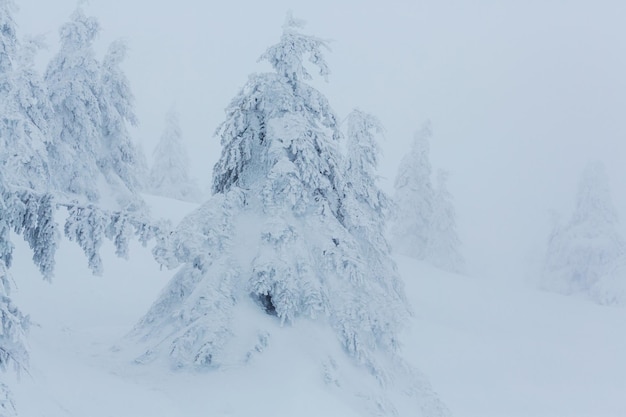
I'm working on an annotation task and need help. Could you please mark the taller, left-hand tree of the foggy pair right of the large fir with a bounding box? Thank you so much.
[391,122,435,260]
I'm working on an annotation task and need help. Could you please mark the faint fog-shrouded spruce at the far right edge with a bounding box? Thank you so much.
[541,162,626,304]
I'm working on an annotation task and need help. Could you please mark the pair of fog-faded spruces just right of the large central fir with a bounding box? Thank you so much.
[391,122,463,272]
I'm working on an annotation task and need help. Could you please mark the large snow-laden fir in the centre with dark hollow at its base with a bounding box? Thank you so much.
[133,16,446,415]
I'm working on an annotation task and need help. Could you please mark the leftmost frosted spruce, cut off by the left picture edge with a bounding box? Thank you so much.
[0,4,57,406]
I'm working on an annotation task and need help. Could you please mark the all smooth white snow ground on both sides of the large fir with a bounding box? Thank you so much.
[7,193,626,417]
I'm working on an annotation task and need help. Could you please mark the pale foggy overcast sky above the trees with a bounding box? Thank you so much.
[16,0,626,277]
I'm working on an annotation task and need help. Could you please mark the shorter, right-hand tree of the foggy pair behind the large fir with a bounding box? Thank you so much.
[424,170,464,272]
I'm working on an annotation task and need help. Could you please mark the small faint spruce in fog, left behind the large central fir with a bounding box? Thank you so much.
[147,110,200,202]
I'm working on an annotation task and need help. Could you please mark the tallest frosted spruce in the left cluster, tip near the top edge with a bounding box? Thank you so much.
[45,8,102,201]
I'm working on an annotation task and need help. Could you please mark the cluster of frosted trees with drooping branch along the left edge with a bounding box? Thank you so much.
[0,4,160,416]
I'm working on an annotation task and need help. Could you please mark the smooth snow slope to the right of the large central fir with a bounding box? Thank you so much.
[397,257,626,417]
